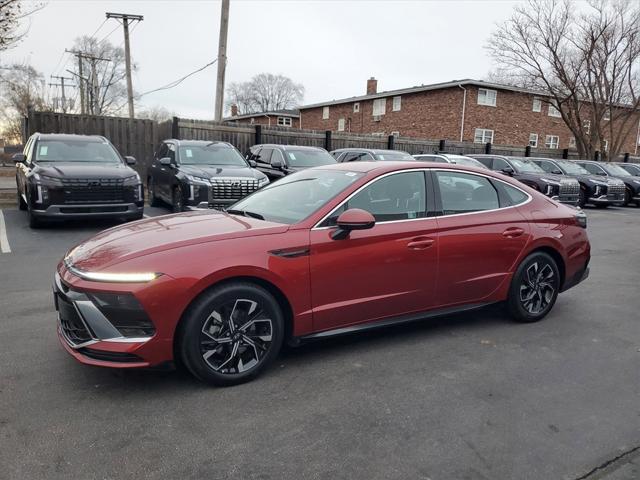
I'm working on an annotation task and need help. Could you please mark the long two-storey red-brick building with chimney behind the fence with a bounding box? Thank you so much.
[300,77,640,154]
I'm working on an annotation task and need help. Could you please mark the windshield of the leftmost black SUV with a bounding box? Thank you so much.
[35,140,122,163]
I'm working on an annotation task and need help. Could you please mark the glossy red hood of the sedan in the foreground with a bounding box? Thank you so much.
[66,210,289,271]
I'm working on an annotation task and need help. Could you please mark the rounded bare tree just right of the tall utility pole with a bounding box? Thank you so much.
[226,73,304,115]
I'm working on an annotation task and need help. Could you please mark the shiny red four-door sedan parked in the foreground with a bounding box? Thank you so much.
[54,162,590,385]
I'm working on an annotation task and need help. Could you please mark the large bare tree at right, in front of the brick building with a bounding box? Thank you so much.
[488,0,640,158]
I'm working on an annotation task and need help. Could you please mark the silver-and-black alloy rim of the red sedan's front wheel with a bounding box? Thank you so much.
[200,298,274,374]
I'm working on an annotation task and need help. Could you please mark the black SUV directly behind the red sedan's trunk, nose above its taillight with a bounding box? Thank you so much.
[468,154,580,205]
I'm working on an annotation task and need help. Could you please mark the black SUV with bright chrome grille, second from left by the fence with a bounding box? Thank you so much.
[147,139,269,212]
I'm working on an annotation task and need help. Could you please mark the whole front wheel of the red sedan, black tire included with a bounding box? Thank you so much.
[176,282,284,386]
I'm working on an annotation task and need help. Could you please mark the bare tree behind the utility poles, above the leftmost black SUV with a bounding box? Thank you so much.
[71,36,132,115]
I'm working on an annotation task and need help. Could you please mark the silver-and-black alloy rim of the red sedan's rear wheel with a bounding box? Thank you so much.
[520,261,557,315]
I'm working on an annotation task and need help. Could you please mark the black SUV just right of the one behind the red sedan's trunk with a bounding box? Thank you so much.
[531,158,624,207]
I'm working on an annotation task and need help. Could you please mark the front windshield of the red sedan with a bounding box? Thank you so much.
[229,170,364,224]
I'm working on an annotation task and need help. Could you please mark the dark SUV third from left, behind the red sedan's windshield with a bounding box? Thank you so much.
[247,144,336,180]
